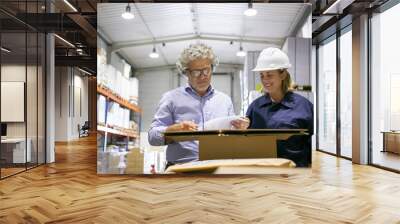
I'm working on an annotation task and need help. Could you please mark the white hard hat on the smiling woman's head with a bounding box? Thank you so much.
[252,47,291,72]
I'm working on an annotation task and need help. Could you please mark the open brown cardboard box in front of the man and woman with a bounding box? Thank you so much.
[164,129,307,173]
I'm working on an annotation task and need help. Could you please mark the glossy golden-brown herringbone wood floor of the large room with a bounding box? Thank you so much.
[0,134,400,224]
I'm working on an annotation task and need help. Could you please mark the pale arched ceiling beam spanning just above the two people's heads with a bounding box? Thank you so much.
[111,33,284,52]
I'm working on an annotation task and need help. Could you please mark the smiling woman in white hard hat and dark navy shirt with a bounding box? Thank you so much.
[246,47,313,167]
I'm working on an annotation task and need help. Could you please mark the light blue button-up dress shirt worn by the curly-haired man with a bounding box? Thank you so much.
[148,85,235,163]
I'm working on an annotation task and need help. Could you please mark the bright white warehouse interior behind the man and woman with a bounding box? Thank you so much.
[97,3,315,174]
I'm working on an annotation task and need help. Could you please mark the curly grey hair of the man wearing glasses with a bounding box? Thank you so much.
[176,44,219,74]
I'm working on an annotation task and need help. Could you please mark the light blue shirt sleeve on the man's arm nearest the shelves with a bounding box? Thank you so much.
[148,94,173,146]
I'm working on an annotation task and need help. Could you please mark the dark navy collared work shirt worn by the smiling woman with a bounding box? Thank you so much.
[246,91,314,167]
